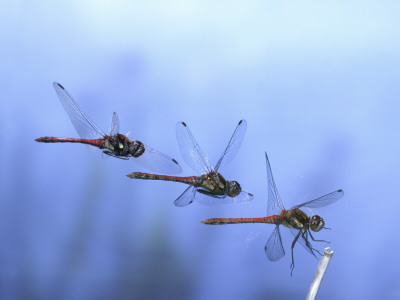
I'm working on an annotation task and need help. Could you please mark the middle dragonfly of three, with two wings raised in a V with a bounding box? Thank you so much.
[127,120,254,207]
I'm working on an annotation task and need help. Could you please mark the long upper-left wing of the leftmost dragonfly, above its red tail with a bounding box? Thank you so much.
[53,82,105,139]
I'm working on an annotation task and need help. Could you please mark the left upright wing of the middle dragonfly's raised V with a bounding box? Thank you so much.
[176,122,213,174]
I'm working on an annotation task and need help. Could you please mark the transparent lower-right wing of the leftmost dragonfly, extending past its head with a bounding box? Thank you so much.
[134,145,182,174]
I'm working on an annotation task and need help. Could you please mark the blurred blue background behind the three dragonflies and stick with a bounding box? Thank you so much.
[0,0,400,299]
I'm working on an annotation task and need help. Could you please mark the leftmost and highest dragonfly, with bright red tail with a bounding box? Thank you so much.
[35,82,182,174]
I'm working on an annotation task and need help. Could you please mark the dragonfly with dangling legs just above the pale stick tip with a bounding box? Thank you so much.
[202,153,343,275]
